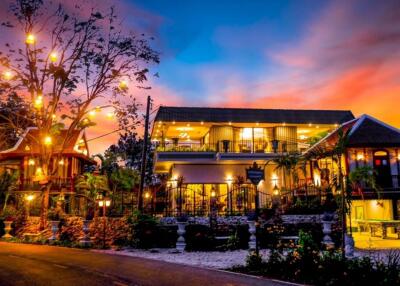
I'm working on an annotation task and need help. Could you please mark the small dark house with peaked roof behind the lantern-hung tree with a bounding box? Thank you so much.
[0,127,96,211]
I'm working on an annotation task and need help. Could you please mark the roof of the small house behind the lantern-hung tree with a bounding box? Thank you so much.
[0,127,92,161]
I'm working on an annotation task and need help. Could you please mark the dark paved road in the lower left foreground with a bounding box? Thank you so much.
[0,242,286,286]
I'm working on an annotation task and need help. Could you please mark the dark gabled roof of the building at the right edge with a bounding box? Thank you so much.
[305,114,400,154]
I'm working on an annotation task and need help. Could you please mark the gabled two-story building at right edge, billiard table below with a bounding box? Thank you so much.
[307,115,400,238]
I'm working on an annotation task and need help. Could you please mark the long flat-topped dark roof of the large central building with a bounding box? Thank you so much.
[155,106,354,124]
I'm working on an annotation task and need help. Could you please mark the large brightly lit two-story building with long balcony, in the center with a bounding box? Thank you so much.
[151,106,354,215]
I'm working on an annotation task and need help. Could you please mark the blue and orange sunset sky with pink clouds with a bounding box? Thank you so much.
[3,0,400,154]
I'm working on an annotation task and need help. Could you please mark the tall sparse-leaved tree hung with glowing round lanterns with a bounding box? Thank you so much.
[0,0,159,228]
